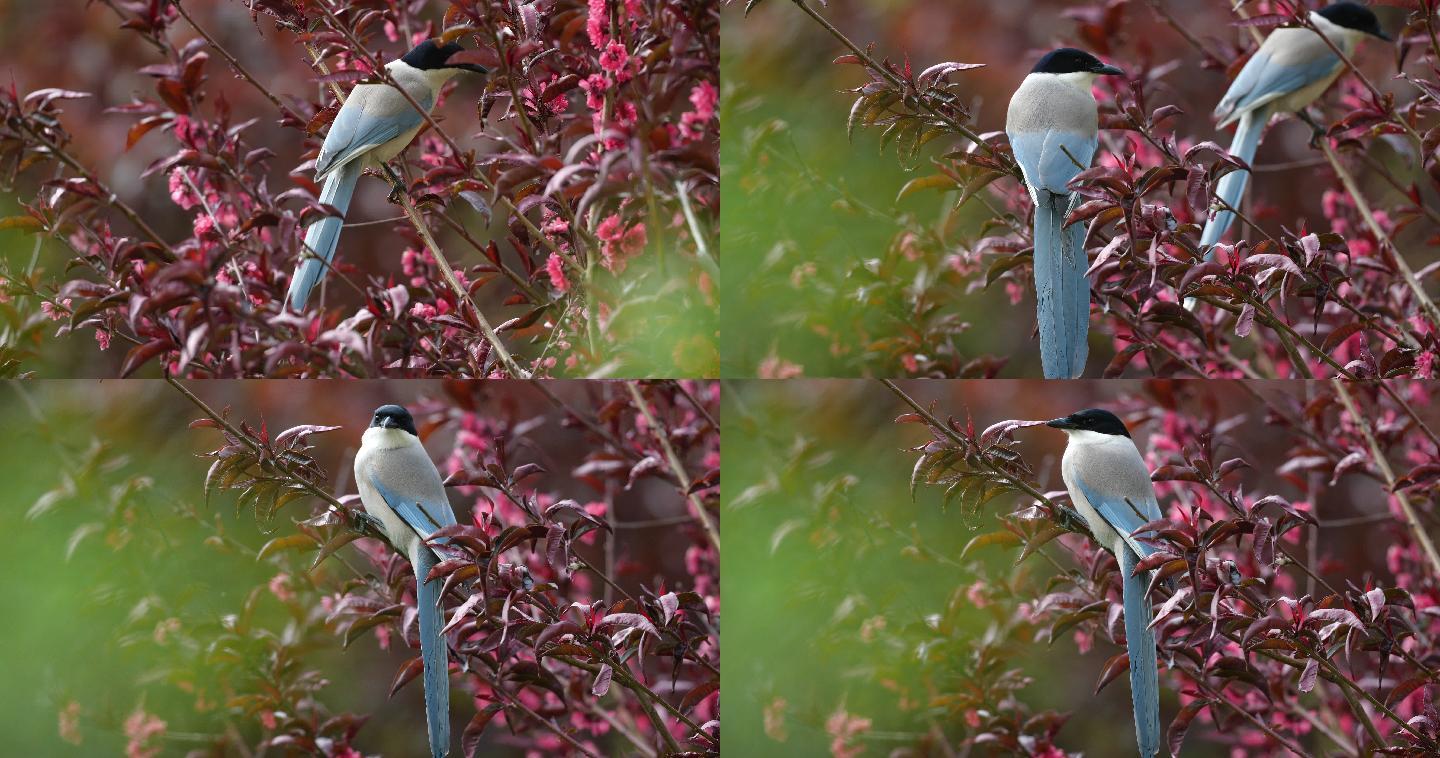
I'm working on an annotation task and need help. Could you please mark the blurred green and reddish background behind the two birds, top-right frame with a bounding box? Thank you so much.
[721,0,1405,378]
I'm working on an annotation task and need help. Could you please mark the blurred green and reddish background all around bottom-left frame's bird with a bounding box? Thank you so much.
[0,380,711,755]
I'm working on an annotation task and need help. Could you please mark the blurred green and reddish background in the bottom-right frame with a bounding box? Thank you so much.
[721,380,1440,758]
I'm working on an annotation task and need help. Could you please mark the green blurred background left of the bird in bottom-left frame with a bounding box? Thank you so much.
[0,380,459,755]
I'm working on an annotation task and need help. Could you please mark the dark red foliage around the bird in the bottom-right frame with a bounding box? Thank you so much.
[899,382,1440,755]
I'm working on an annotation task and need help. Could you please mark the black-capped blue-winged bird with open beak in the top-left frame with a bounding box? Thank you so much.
[285,39,487,311]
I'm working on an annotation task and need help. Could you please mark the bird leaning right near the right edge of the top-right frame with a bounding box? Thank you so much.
[1187,3,1390,269]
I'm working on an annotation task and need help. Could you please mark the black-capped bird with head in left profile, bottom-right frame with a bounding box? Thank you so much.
[1048,408,1161,758]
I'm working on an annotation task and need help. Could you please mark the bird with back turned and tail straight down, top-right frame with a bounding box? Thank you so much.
[1005,48,1125,379]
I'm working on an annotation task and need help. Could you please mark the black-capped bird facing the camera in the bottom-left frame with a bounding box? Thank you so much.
[354,405,455,758]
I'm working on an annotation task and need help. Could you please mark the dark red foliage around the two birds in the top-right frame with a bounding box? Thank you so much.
[746,1,1440,378]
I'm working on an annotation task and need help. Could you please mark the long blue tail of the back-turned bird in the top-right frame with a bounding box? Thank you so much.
[1035,190,1090,379]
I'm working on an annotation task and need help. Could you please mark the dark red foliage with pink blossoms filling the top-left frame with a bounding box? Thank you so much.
[0,0,719,378]
